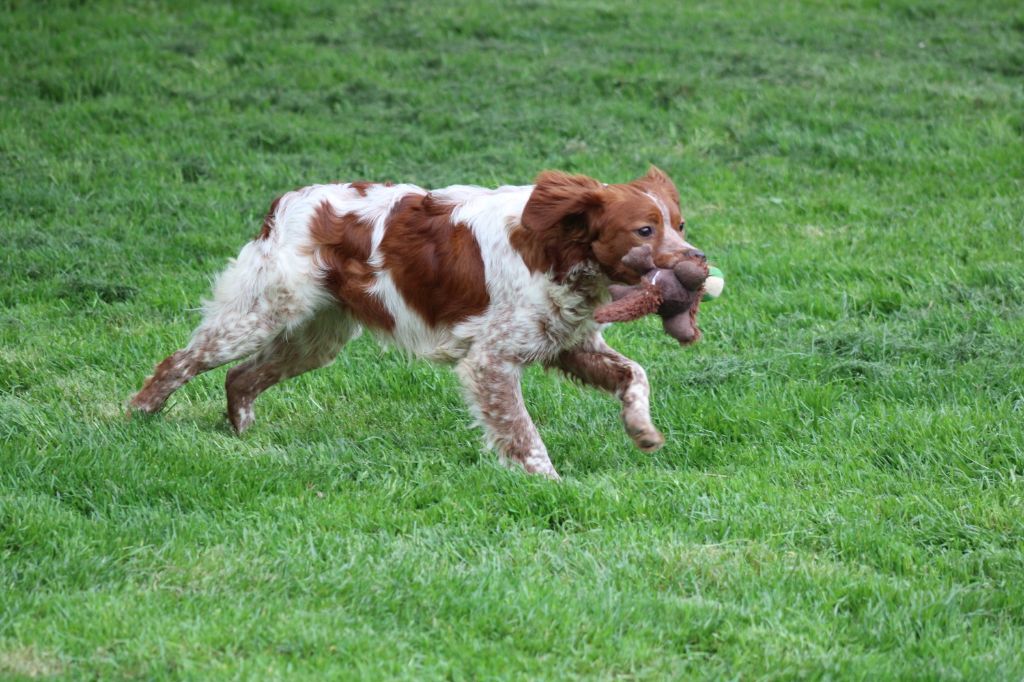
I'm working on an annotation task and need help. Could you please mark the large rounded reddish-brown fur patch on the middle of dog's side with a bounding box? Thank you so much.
[380,195,490,326]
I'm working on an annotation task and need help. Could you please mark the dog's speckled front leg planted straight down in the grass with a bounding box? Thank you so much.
[456,352,559,480]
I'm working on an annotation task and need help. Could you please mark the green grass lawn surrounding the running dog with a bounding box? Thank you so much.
[0,0,1024,680]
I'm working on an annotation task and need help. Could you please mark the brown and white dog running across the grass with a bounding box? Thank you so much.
[129,168,703,478]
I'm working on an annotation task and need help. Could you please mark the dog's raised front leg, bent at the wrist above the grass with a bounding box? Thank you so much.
[553,336,665,453]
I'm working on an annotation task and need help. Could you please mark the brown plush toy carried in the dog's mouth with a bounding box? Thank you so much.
[594,245,708,346]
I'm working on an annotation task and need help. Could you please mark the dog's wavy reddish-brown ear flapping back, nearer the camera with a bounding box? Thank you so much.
[522,171,602,238]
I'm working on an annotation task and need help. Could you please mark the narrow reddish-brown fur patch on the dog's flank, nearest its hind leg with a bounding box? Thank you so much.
[309,201,394,331]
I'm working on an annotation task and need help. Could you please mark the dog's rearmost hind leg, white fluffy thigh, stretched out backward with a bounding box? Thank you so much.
[128,241,329,414]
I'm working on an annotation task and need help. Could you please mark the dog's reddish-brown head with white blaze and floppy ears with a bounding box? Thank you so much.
[516,166,703,284]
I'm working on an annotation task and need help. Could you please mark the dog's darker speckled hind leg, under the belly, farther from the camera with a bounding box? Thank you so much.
[224,306,361,433]
